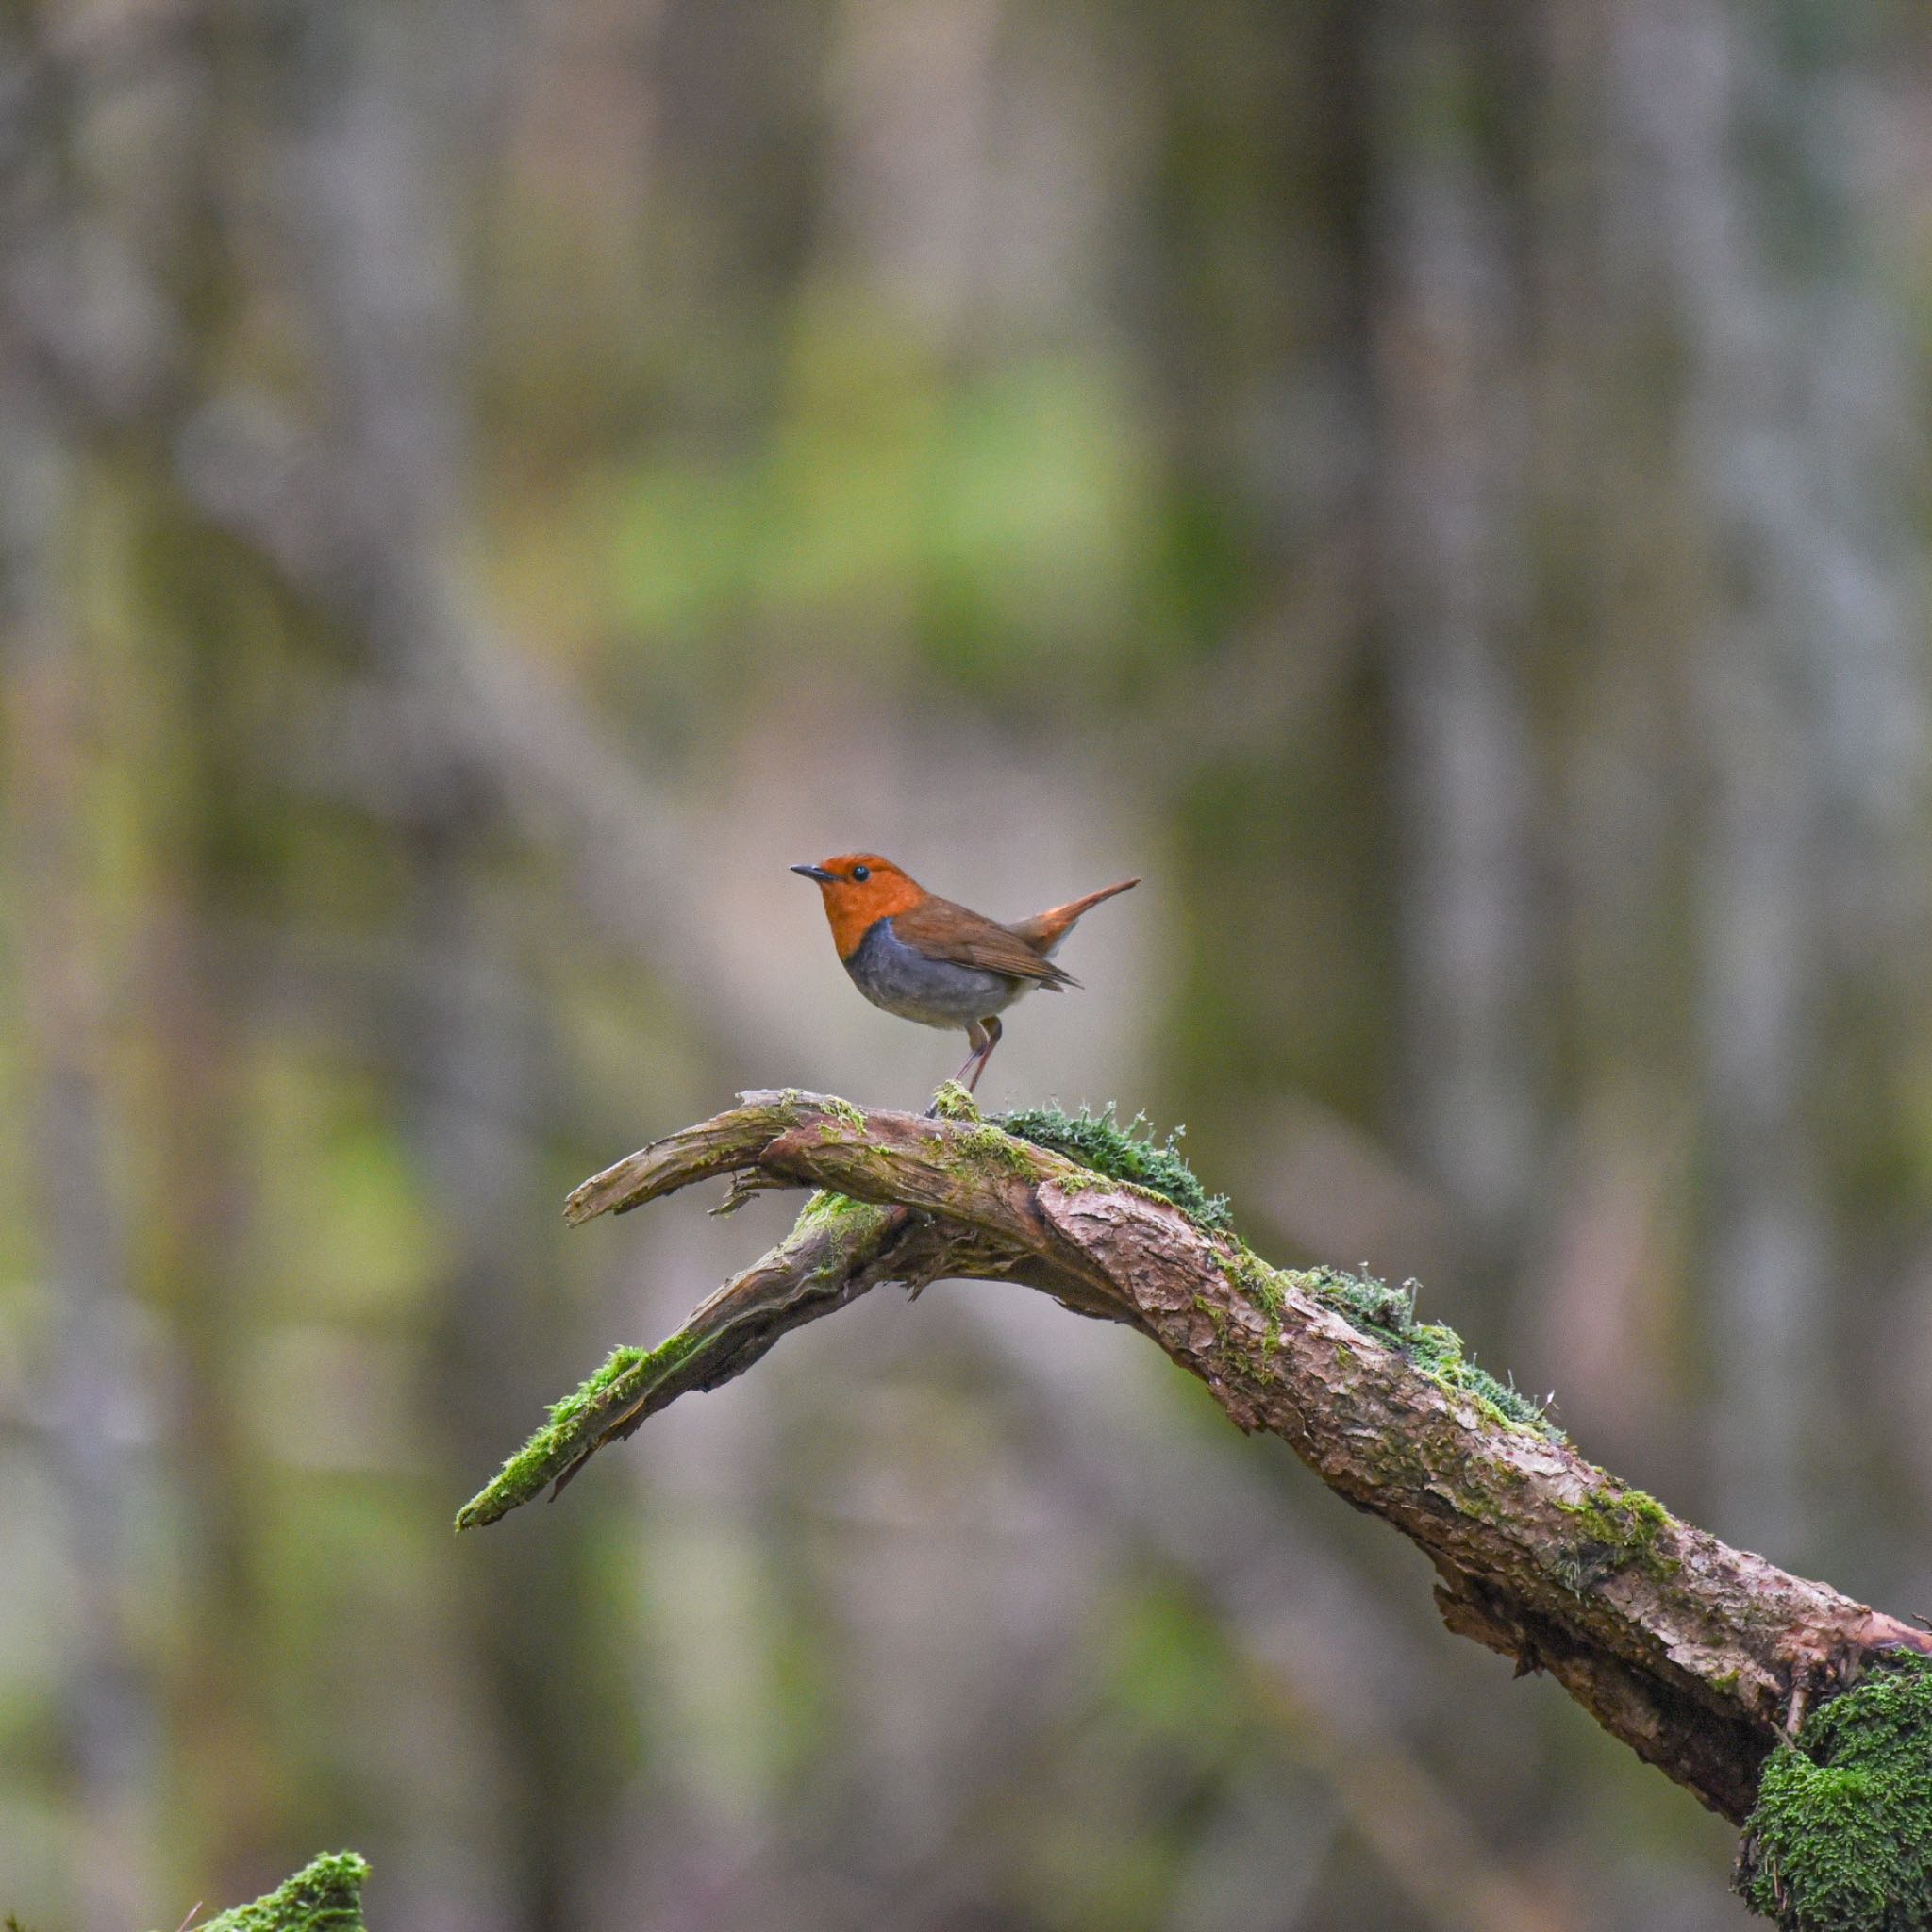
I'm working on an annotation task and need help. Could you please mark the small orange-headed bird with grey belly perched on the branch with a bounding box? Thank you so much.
[792,852,1140,1091]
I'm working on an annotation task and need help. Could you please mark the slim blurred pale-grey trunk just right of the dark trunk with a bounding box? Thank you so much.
[1368,0,1540,1263]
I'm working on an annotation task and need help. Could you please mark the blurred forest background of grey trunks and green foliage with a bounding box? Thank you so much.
[0,0,1932,1932]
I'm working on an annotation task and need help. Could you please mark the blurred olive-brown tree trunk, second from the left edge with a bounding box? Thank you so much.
[107,22,288,1893]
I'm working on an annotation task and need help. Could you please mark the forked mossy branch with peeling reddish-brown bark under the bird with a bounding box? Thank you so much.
[458,1090,1932,1822]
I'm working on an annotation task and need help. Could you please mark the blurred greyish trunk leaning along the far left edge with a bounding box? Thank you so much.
[0,297,157,1932]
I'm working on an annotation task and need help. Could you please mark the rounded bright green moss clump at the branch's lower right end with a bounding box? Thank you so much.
[1737,1657,1932,1932]
